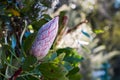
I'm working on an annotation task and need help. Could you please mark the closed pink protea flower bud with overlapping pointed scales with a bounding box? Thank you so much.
[31,17,59,60]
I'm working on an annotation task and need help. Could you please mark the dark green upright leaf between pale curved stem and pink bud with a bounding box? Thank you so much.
[23,33,36,53]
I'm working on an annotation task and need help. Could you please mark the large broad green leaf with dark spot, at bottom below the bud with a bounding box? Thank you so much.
[39,63,68,80]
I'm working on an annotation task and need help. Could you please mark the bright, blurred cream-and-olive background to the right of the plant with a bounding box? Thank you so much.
[48,0,120,80]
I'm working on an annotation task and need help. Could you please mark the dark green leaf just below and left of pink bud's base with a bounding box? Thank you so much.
[22,55,37,71]
